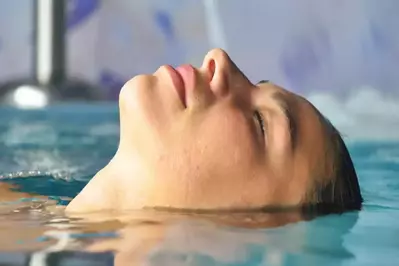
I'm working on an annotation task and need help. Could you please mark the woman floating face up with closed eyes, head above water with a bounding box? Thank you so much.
[66,49,362,213]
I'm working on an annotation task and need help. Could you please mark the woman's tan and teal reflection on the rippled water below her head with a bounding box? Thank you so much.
[0,184,358,265]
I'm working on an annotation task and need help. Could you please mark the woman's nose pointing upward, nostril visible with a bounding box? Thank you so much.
[201,48,252,96]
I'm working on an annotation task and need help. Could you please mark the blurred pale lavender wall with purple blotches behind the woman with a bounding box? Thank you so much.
[0,0,399,140]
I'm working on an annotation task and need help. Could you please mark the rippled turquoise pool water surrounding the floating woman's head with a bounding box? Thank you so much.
[0,104,399,266]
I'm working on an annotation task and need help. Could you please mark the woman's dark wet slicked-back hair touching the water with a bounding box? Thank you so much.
[304,117,363,215]
